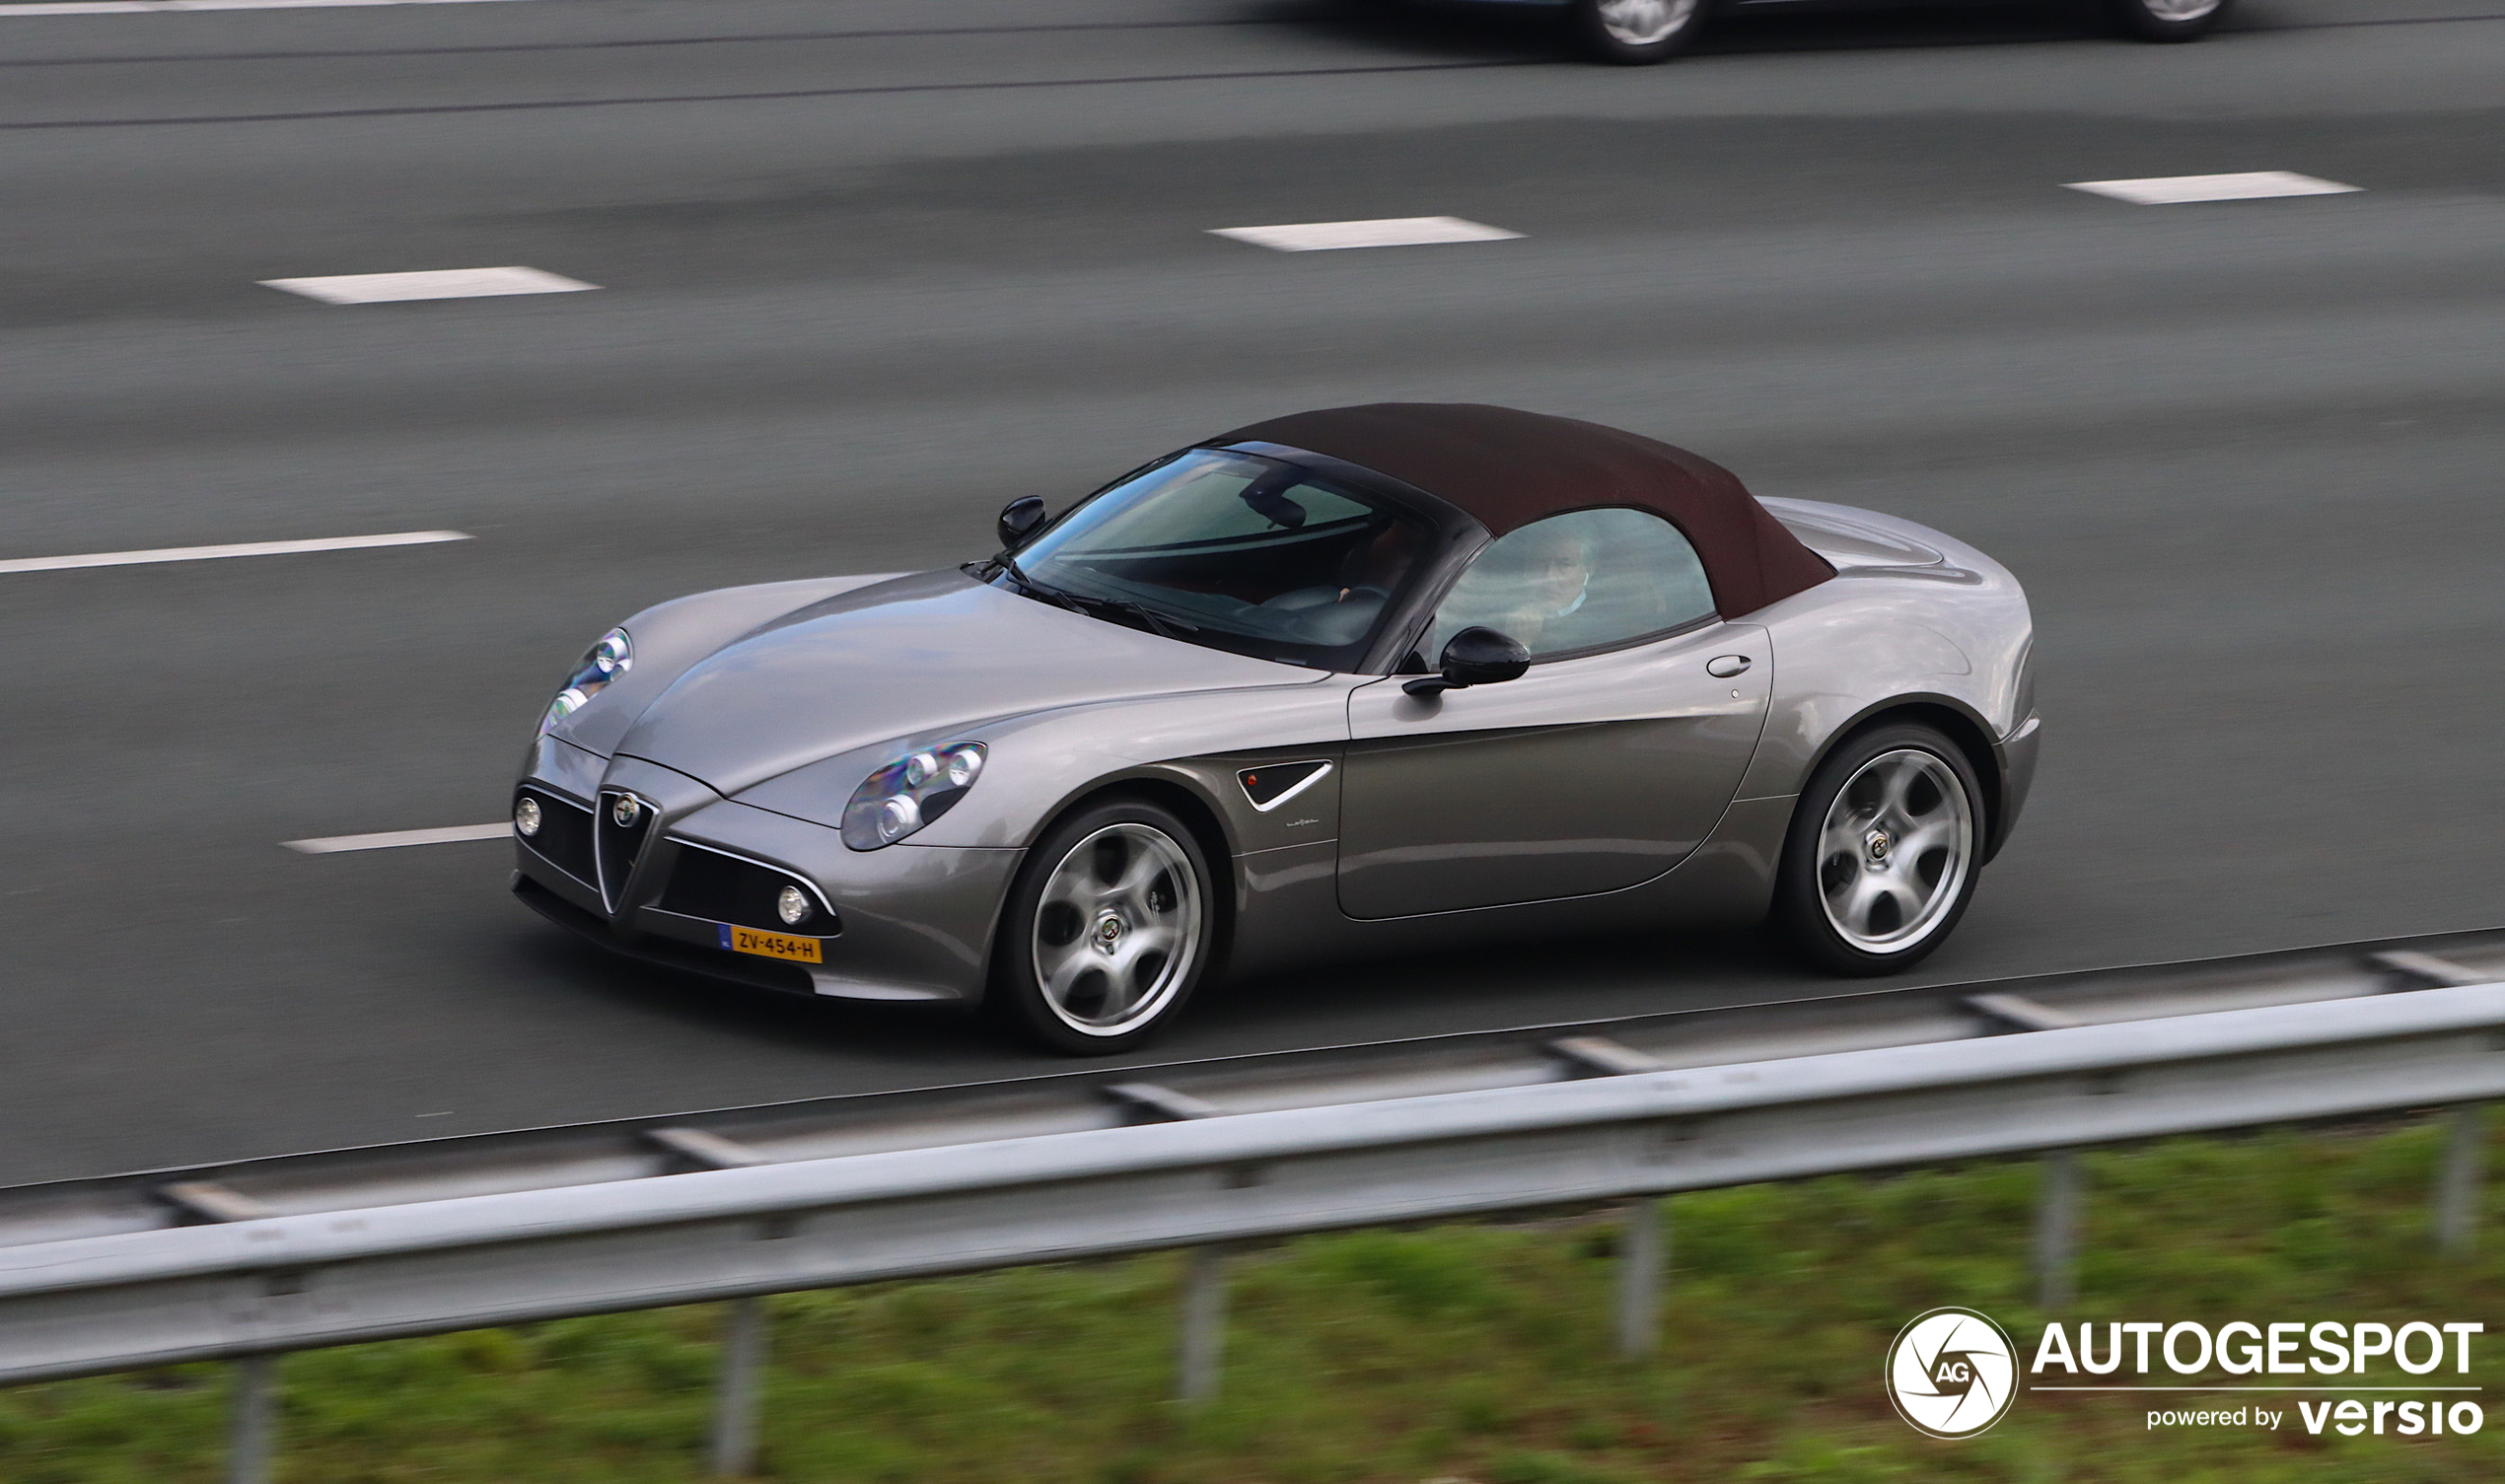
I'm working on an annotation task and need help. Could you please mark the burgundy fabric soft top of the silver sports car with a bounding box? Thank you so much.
[1210,403,1836,618]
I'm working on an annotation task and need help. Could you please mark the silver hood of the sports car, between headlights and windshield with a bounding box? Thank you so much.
[618,573,1323,796]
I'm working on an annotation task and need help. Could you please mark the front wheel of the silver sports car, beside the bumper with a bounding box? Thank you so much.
[984,799,1220,1056]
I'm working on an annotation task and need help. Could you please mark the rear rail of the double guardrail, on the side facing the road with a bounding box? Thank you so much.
[14,931,2505,1248]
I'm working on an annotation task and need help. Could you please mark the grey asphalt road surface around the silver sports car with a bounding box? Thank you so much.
[0,0,2505,1181]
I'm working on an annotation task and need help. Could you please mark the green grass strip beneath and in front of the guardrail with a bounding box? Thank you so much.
[0,1110,2505,1484]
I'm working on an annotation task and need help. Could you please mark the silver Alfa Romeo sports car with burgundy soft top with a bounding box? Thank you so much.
[514,403,2037,1051]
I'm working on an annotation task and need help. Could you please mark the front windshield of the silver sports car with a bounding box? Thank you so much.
[1005,448,1433,671]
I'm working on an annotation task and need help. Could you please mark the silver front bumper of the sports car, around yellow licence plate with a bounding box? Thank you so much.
[514,758,1022,1001]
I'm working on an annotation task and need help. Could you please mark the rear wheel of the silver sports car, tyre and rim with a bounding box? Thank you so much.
[1773,723,1986,976]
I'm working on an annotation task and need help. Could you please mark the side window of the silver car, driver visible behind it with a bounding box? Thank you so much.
[1423,511,1713,664]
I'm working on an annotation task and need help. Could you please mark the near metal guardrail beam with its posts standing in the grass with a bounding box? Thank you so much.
[0,931,2505,1479]
